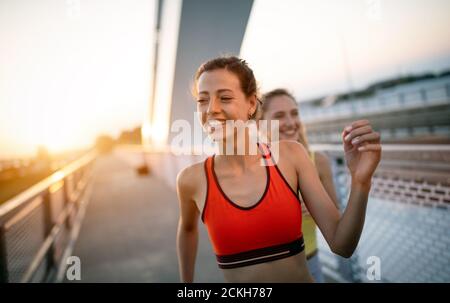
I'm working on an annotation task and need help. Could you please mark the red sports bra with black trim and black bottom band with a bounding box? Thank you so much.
[202,144,304,268]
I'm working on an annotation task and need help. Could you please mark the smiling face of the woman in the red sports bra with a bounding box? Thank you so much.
[196,69,256,140]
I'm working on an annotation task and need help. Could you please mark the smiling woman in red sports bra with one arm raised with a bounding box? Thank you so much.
[177,57,381,282]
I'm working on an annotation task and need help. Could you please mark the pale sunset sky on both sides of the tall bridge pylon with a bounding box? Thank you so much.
[0,0,450,157]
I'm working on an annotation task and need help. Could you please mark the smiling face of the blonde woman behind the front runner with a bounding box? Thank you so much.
[264,96,301,141]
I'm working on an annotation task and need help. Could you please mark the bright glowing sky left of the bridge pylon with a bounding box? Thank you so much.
[0,0,155,157]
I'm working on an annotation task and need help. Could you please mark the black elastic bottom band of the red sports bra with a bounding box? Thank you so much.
[216,236,305,269]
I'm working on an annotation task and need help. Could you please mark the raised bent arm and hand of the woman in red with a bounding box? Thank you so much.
[290,120,381,258]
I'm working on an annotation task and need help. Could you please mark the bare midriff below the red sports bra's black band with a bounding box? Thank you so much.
[222,251,314,283]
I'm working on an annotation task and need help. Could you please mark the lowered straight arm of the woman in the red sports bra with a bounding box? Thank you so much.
[177,168,199,282]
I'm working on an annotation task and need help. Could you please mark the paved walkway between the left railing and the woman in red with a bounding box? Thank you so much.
[68,154,223,282]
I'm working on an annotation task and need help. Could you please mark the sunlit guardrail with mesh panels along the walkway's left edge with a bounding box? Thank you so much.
[0,151,97,283]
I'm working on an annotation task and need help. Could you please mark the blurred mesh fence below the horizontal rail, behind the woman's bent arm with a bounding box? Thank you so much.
[315,145,450,282]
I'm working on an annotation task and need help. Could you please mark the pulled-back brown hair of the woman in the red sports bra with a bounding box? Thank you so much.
[192,56,261,120]
